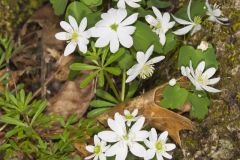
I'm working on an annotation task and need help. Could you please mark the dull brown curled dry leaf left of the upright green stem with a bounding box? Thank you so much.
[47,72,94,118]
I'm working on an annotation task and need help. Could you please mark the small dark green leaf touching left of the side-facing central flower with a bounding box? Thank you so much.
[118,52,135,70]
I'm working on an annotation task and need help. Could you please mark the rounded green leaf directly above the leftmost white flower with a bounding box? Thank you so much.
[65,1,92,23]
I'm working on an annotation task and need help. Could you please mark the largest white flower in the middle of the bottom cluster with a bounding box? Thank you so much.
[98,113,149,160]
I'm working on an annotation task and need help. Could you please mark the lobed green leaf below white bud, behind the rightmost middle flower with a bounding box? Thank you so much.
[178,44,218,69]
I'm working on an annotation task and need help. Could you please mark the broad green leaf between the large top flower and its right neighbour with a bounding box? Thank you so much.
[133,21,163,53]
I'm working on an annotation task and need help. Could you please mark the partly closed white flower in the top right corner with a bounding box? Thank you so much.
[206,0,228,25]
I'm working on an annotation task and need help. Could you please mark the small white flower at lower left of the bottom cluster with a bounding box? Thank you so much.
[85,135,109,160]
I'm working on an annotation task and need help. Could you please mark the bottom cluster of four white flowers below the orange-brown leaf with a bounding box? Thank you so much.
[85,109,176,160]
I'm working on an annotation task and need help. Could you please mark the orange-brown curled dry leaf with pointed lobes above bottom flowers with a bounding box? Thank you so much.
[97,78,195,146]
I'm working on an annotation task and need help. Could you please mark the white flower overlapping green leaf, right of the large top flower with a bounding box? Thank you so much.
[145,7,175,46]
